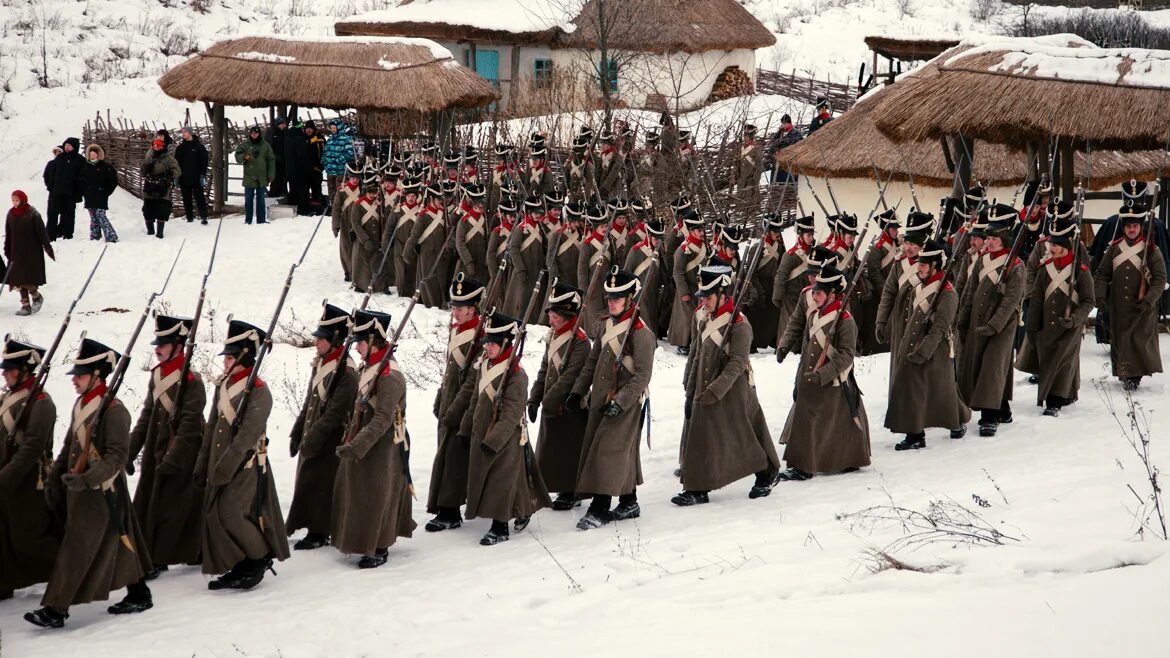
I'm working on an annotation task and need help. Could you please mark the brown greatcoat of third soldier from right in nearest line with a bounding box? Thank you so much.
[957,253,1025,410]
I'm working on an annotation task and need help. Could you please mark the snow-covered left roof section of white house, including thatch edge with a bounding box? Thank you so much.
[333,0,572,46]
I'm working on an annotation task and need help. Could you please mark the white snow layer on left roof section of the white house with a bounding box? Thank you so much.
[343,0,579,34]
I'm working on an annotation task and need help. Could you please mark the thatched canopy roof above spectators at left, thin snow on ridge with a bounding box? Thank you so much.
[158,36,500,111]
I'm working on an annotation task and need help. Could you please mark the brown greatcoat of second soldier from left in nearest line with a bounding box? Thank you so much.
[41,388,152,611]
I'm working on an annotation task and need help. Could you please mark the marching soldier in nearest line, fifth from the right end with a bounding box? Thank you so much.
[776,266,869,480]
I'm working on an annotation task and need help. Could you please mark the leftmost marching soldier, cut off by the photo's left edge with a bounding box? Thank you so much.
[0,338,60,601]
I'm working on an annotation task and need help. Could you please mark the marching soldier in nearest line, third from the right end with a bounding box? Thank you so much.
[959,209,1025,437]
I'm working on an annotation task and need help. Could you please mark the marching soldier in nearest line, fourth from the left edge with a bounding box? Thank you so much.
[195,320,289,590]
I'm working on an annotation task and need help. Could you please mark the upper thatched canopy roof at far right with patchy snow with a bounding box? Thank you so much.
[878,42,1170,151]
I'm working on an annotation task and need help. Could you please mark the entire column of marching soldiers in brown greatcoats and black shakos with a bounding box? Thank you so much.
[0,118,1165,628]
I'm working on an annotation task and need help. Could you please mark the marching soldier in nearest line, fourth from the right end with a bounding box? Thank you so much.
[886,240,971,451]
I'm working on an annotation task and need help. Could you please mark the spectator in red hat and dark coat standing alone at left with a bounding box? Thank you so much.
[4,190,56,315]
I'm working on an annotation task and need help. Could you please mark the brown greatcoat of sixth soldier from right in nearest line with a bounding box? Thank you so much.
[682,308,780,492]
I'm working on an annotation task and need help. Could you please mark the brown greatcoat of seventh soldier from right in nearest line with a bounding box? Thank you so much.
[573,314,659,495]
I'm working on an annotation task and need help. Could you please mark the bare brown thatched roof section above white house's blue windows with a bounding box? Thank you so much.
[556,0,776,53]
